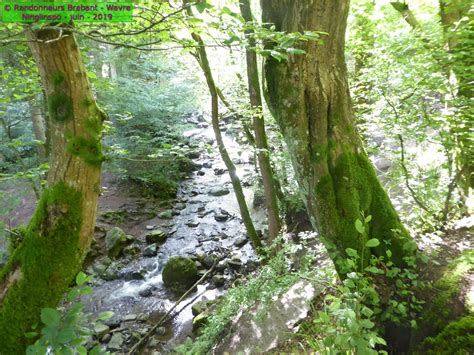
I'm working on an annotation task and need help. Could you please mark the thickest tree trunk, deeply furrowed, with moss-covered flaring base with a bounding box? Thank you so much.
[262,0,414,271]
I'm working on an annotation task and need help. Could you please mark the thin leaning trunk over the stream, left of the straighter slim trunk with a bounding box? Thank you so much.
[185,1,262,252]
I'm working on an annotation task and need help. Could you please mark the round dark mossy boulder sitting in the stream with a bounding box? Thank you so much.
[163,256,199,292]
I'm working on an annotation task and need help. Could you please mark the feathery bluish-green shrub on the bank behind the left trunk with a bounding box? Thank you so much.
[90,51,199,198]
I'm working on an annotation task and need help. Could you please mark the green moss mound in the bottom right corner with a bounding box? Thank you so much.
[423,314,474,355]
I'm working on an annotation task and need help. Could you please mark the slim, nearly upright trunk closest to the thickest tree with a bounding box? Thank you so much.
[240,0,281,240]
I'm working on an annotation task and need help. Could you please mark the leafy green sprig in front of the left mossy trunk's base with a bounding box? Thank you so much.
[26,272,113,355]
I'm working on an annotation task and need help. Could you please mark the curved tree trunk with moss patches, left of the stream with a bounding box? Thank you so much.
[0,30,105,354]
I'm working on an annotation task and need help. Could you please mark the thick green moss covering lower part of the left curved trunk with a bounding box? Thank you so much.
[0,183,82,354]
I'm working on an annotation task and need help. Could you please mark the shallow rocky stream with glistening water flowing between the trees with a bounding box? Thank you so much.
[85,117,265,354]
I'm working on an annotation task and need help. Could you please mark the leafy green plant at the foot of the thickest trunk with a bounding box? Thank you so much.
[301,216,428,354]
